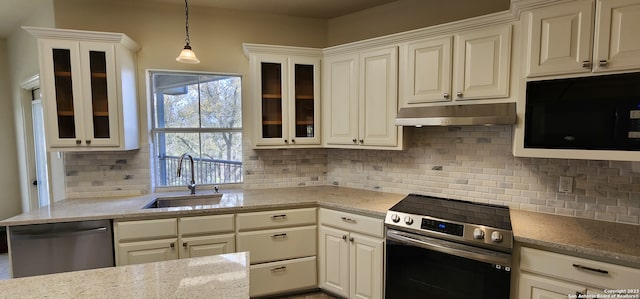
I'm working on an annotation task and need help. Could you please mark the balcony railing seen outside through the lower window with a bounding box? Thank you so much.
[158,156,243,186]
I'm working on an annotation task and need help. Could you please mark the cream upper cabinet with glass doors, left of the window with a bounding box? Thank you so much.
[23,27,139,151]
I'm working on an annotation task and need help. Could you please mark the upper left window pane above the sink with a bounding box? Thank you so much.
[153,74,200,128]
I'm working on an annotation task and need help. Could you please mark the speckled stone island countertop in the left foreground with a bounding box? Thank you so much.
[0,252,249,299]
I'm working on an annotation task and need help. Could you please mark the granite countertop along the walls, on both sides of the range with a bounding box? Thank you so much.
[0,186,640,268]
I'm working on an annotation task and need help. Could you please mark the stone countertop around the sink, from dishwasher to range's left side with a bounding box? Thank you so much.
[0,186,405,226]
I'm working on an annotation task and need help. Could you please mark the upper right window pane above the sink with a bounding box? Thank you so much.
[200,76,242,128]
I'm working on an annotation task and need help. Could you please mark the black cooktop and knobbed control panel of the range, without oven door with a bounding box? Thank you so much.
[385,194,513,252]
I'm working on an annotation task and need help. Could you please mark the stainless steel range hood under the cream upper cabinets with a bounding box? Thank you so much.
[396,103,516,127]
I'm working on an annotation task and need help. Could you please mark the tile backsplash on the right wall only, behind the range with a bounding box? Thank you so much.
[327,126,640,224]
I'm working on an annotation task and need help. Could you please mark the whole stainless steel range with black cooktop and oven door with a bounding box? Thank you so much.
[385,194,513,299]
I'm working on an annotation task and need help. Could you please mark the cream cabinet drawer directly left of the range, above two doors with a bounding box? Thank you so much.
[320,209,384,238]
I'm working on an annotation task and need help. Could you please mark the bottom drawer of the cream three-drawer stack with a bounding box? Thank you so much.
[249,256,317,297]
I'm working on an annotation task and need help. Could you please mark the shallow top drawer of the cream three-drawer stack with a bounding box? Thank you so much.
[237,208,317,231]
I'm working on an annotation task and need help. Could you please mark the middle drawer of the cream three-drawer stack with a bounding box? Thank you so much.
[236,225,317,264]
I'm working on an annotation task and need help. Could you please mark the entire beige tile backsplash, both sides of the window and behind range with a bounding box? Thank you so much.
[65,126,640,224]
